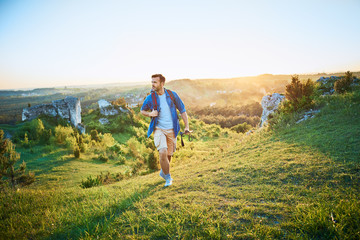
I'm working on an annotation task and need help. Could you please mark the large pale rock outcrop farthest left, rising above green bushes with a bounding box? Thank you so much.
[22,96,85,133]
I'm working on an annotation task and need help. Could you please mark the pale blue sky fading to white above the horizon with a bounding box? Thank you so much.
[0,0,360,89]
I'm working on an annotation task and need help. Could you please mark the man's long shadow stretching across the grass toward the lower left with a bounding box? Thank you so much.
[47,182,162,239]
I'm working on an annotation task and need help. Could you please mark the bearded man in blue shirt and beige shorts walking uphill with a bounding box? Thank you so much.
[141,74,190,187]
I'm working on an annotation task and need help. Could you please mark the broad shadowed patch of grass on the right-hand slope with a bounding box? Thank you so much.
[274,108,360,164]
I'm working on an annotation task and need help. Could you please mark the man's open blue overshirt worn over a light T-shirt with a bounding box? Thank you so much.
[141,89,186,137]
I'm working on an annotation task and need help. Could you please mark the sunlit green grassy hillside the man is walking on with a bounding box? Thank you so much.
[0,87,360,239]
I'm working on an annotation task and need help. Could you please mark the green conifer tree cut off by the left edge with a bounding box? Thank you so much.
[0,129,35,189]
